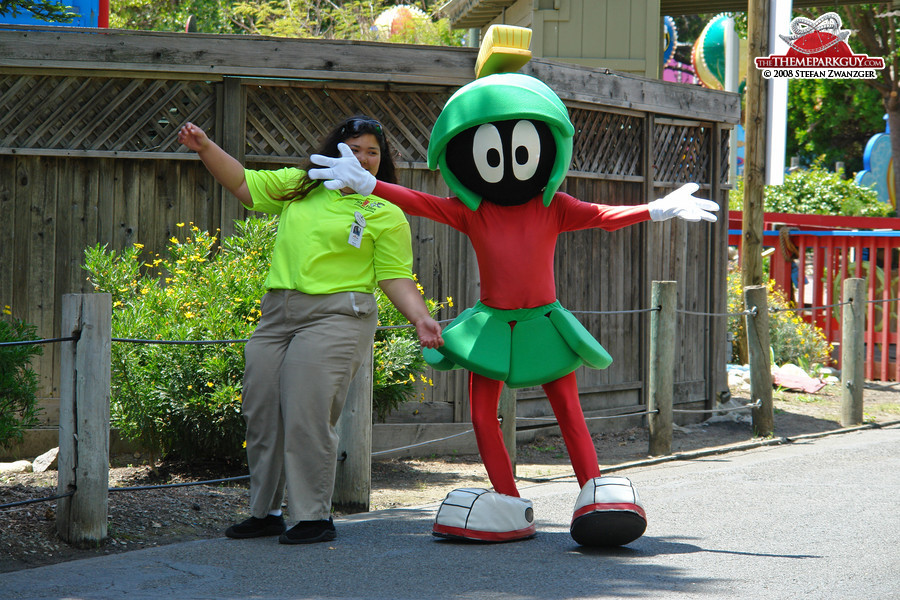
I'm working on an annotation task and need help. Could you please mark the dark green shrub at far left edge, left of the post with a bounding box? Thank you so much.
[0,306,43,448]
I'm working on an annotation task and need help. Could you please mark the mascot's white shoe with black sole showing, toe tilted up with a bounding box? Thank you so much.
[569,477,647,547]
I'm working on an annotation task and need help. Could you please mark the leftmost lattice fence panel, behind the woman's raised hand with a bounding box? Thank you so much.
[0,75,215,153]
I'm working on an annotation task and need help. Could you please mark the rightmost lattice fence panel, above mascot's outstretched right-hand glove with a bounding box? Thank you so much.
[653,122,712,183]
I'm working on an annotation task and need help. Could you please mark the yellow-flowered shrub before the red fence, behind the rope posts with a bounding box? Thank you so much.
[728,270,832,373]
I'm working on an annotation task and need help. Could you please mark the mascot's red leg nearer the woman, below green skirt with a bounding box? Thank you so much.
[469,373,516,498]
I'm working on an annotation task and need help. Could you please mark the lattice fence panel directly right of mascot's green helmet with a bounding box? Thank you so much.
[569,108,644,176]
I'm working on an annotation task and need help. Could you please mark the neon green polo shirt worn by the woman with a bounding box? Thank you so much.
[244,167,412,294]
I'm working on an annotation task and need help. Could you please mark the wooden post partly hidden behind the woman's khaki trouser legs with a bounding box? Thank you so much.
[332,349,374,513]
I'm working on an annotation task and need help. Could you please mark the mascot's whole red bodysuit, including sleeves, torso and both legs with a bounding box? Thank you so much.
[373,181,650,496]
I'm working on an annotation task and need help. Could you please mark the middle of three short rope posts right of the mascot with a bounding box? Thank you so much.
[744,285,775,437]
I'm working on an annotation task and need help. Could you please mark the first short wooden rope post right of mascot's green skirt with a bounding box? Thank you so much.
[647,281,678,456]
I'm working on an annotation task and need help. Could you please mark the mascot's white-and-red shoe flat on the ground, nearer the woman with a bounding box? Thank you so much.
[432,488,535,542]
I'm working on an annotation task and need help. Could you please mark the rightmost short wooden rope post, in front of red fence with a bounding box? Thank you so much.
[841,278,867,427]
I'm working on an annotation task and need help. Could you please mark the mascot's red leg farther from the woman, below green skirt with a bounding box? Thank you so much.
[536,372,600,487]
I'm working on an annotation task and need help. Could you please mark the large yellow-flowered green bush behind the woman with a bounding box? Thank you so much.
[85,218,437,459]
